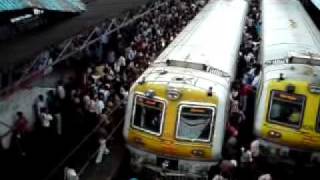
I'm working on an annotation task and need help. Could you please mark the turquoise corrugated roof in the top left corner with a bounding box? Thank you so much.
[0,0,86,13]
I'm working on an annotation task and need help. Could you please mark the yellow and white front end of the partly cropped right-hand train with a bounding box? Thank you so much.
[255,55,320,163]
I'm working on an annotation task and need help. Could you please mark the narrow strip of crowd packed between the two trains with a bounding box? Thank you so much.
[209,0,273,180]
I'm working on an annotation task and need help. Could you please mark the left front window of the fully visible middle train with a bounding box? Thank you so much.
[132,95,164,135]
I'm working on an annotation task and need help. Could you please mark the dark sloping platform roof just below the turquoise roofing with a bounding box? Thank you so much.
[0,0,151,70]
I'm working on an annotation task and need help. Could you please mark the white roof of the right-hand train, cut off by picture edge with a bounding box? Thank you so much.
[262,0,320,63]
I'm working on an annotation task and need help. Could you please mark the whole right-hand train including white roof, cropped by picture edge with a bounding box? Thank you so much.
[254,0,320,163]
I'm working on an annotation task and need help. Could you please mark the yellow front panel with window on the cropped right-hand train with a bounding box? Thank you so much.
[262,80,320,150]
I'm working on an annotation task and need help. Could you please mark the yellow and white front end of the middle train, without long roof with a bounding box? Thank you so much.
[124,67,227,177]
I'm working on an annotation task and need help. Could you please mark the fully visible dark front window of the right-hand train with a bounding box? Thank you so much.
[269,91,305,128]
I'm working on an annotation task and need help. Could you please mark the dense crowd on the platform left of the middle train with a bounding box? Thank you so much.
[4,0,207,179]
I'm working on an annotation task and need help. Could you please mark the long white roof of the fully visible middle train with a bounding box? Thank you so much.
[155,0,248,79]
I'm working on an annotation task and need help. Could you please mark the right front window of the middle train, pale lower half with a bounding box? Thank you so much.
[176,105,215,142]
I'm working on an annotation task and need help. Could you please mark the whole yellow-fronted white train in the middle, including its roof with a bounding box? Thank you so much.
[123,0,248,176]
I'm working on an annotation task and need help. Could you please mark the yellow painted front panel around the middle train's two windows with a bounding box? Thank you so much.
[128,83,217,160]
